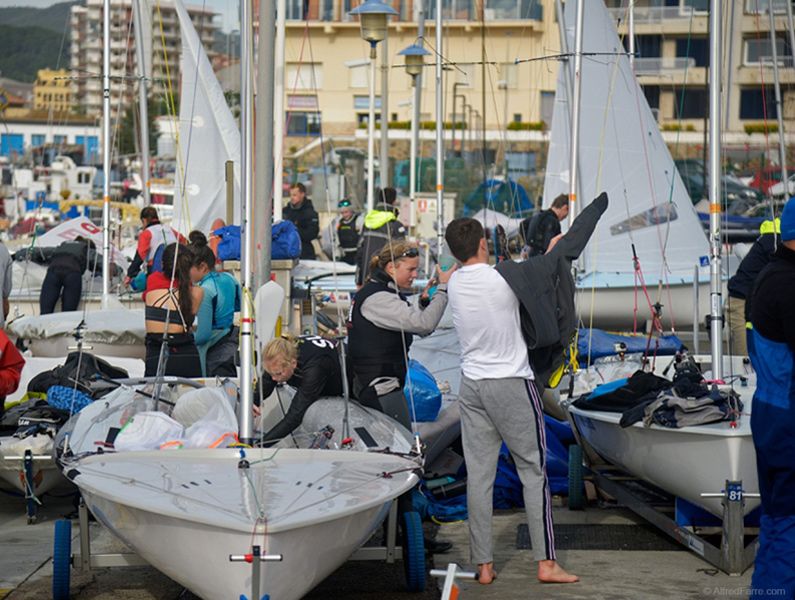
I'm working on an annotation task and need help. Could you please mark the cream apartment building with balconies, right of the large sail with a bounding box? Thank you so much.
[607,0,795,144]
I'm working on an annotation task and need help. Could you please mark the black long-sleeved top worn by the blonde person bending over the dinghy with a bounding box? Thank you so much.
[261,336,342,442]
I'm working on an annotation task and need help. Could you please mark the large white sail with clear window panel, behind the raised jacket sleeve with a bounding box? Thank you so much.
[543,0,709,277]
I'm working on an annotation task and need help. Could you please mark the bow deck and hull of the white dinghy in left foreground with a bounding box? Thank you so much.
[66,449,417,600]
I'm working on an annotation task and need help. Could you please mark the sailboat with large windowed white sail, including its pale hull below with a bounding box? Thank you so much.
[543,0,709,329]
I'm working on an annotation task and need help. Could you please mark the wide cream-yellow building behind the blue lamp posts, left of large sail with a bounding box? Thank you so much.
[285,0,558,146]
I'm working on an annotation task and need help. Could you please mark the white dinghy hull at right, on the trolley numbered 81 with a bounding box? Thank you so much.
[569,406,759,517]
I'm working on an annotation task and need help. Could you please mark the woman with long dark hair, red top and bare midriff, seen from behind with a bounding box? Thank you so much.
[144,244,204,377]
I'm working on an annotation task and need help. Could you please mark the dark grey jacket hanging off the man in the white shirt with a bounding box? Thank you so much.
[496,192,608,385]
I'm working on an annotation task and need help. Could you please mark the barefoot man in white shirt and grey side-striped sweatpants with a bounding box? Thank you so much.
[445,218,579,584]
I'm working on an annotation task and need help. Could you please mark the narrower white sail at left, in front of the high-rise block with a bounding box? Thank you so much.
[172,0,240,233]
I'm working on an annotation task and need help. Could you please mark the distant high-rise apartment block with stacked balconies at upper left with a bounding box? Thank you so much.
[69,0,218,116]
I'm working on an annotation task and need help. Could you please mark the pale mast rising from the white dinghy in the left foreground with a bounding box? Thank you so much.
[238,0,255,444]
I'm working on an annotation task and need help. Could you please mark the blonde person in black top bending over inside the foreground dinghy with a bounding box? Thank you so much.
[258,334,343,444]
